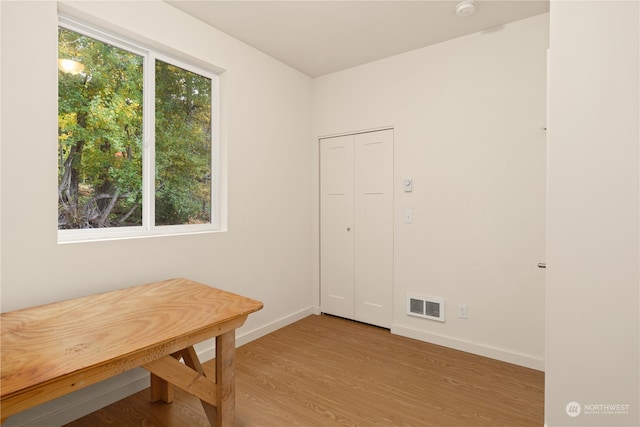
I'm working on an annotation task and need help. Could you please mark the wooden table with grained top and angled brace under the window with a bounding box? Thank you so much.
[0,279,262,426]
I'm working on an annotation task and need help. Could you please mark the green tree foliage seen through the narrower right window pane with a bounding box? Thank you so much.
[156,61,211,225]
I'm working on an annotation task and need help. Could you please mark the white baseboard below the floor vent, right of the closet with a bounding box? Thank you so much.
[391,325,544,371]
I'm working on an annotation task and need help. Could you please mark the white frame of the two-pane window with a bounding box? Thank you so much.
[58,15,222,243]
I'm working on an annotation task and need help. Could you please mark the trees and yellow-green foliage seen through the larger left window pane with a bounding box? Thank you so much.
[58,27,143,229]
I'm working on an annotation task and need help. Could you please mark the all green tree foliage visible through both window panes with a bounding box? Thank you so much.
[58,27,212,229]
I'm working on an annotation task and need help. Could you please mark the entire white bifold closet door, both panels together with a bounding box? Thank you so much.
[320,129,393,327]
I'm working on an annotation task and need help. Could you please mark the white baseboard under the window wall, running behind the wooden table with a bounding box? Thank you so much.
[2,307,314,427]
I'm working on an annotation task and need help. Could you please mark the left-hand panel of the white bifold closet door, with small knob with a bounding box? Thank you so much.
[320,135,354,319]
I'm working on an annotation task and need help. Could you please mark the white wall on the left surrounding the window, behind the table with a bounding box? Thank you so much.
[0,1,313,425]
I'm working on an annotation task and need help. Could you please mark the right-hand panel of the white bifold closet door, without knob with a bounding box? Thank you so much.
[354,130,393,328]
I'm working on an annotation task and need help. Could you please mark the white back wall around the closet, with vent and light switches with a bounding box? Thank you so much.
[313,14,549,369]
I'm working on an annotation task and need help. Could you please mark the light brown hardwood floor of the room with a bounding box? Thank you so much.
[67,315,544,427]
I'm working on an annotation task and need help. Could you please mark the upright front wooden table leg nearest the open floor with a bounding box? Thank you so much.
[216,330,236,427]
